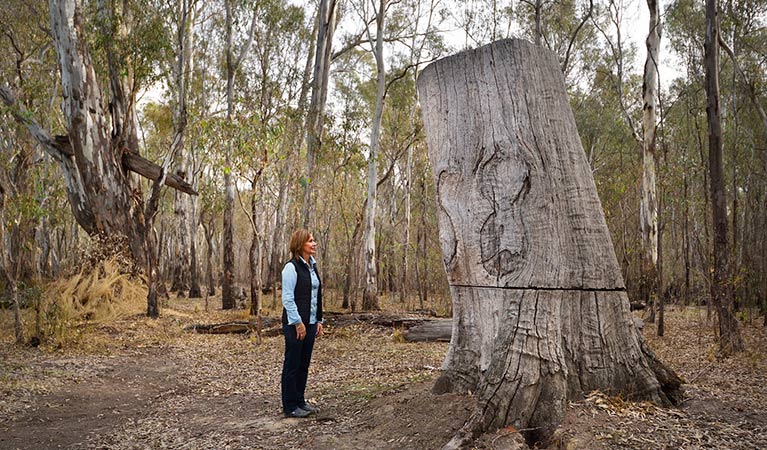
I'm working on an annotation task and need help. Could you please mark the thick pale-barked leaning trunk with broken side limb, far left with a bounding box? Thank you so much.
[50,0,144,263]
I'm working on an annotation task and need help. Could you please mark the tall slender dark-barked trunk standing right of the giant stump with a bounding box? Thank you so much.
[705,0,744,353]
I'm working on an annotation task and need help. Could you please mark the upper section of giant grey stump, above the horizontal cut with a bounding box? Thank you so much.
[418,40,625,290]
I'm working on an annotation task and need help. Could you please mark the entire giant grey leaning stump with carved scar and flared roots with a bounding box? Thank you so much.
[418,40,680,448]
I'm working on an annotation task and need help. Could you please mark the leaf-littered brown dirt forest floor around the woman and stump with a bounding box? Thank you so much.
[0,299,767,450]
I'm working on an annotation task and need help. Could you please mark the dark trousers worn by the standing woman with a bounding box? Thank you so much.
[282,324,317,412]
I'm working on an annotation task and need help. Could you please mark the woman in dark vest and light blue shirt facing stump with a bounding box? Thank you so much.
[282,228,322,417]
